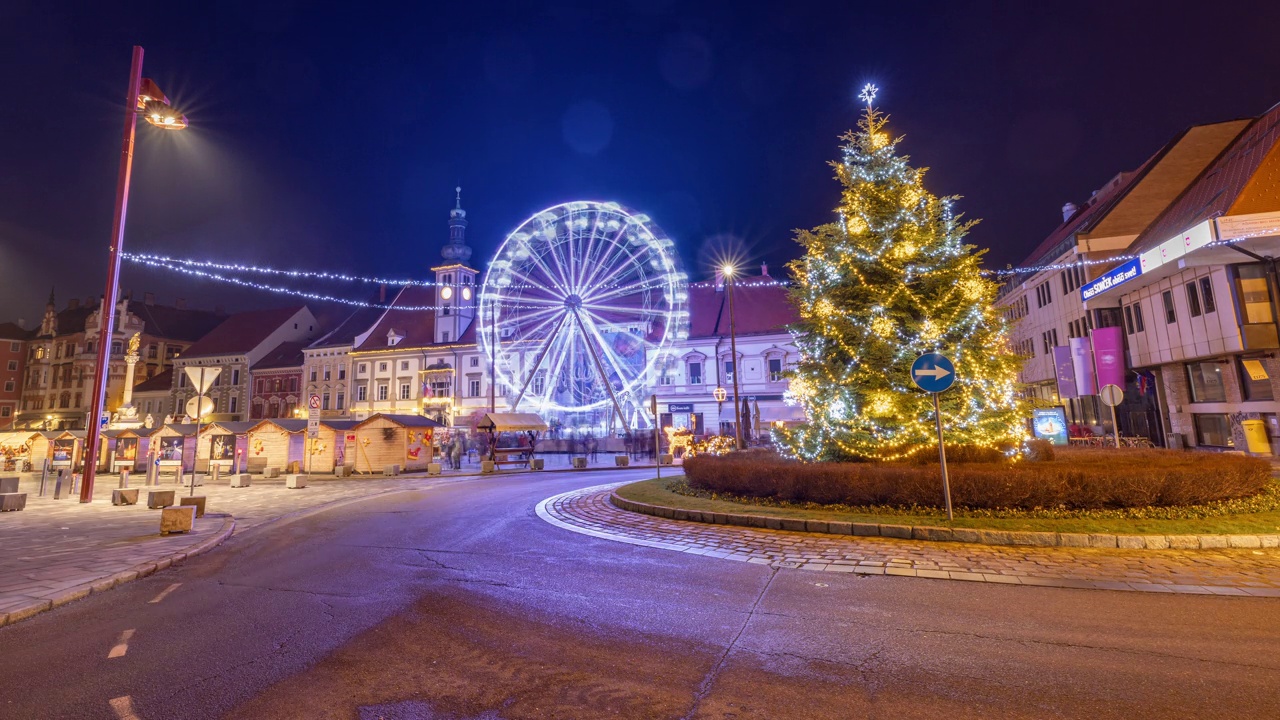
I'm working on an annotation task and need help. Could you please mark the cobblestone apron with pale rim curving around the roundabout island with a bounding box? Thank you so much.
[538,483,1280,597]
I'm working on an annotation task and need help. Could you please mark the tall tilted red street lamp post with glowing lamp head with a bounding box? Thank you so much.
[81,45,187,502]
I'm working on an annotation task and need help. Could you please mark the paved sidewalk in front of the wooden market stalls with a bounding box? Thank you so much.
[0,475,435,625]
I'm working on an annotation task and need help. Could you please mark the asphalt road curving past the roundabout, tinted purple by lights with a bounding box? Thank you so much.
[0,471,1280,720]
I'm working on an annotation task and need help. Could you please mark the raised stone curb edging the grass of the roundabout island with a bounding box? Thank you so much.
[609,492,1280,550]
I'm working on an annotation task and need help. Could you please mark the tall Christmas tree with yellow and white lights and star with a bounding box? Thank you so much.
[780,86,1025,460]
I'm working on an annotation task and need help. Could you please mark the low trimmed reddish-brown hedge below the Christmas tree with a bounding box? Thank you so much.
[684,448,1271,510]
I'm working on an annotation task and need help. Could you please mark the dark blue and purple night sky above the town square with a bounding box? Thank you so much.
[0,0,1280,327]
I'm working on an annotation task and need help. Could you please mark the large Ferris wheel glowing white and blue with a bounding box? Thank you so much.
[477,202,689,428]
